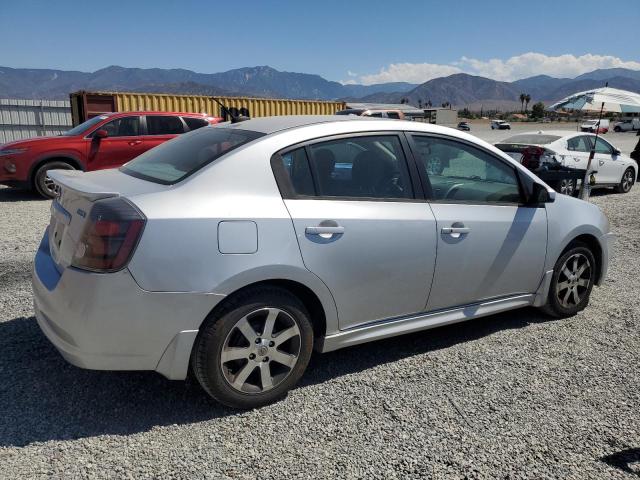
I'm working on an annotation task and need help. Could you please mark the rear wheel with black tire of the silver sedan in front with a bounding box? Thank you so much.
[191,287,313,409]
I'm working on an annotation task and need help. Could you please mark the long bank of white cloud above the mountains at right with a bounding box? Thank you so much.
[350,52,640,85]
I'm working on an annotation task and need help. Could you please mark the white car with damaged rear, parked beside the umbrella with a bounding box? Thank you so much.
[496,131,638,195]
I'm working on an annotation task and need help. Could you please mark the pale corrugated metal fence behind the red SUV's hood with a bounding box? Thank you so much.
[0,99,72,144]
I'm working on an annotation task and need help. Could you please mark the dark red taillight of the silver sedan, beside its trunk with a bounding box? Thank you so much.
[71,198,146,272]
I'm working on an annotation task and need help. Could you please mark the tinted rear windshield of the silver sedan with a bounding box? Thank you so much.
[120,127,264,185]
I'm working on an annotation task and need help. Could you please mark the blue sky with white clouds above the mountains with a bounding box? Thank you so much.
[0,0,640,83]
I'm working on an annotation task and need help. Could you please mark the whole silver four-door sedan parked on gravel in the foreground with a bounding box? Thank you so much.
[33,116,611,408]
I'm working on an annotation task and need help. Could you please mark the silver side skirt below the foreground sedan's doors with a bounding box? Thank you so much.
[319,294,537,352]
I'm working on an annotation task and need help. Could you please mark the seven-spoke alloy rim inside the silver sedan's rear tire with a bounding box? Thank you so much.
[220,307,301,394]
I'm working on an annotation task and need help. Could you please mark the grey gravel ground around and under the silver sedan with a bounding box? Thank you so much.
[0,134,640,480]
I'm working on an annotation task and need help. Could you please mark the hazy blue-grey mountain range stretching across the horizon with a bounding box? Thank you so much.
[0,66,640,110]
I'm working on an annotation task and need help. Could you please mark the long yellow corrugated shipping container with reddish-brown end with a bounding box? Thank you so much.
[69,91,346,126]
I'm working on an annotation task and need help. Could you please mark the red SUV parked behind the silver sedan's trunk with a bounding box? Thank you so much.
[0,112,222,198]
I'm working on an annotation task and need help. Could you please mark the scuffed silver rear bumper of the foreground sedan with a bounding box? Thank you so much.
[32,233,224,380]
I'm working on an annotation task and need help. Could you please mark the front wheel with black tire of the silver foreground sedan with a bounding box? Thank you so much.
[542,242,597,318]
